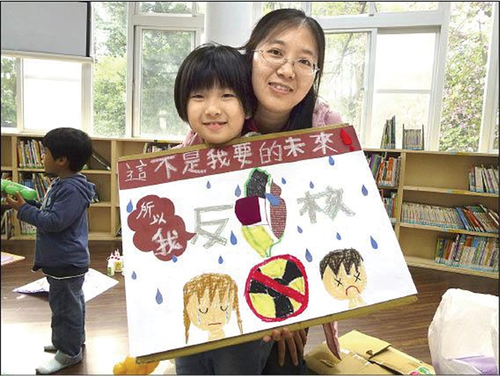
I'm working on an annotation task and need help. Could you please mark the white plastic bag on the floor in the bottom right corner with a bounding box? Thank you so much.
[429,289,498,374]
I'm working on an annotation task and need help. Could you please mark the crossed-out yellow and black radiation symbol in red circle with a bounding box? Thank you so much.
[245,255,309,322]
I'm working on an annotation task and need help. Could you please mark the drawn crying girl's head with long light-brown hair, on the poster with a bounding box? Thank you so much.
[184,274,243,343]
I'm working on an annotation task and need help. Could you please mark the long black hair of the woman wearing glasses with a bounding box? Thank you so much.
[240,9,325,130]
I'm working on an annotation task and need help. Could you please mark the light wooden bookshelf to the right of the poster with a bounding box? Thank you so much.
[364,149,498,279]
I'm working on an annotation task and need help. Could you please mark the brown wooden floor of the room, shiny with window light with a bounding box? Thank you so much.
[1,242,498,375]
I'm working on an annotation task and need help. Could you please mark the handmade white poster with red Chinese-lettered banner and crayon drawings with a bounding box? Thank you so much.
[118,125,416,359]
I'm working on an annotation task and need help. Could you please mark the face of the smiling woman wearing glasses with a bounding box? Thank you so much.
[252,27,318,125]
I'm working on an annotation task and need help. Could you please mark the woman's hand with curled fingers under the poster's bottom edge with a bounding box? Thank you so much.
[263,328,307,367]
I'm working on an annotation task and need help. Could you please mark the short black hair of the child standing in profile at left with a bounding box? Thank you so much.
[42,127,92,172]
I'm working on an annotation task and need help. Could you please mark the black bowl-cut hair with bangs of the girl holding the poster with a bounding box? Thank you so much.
[174,43,253,122]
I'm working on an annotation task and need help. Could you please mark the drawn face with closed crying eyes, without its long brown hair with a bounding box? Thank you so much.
[186,289,233,340]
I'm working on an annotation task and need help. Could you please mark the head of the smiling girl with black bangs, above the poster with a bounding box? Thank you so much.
[174,43,252,145]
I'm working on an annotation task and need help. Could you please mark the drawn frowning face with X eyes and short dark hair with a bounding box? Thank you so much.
[320,248,367,308]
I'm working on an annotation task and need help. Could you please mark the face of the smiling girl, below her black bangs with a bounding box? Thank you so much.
[187,86,245,145]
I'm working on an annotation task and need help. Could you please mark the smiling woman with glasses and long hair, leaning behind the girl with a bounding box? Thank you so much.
[176,9,342,374]
